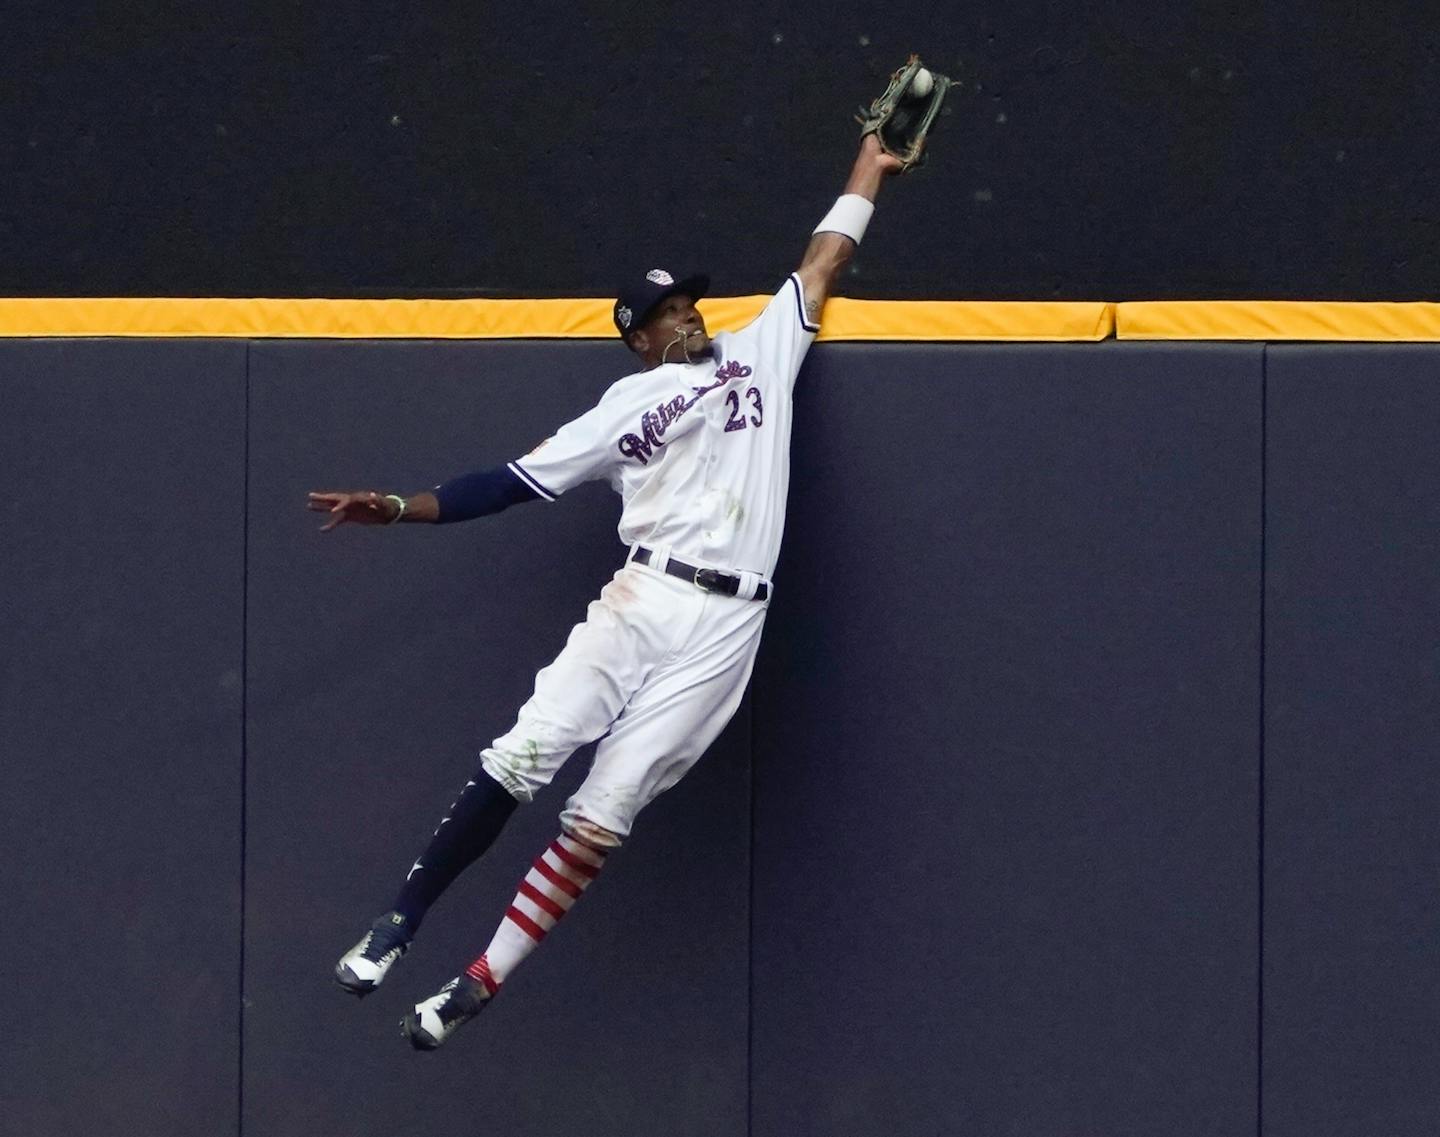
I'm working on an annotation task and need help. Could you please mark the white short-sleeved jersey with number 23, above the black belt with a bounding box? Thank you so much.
[510,275,819,577]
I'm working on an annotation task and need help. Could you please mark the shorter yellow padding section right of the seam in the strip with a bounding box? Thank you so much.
[1116,299,1440,343]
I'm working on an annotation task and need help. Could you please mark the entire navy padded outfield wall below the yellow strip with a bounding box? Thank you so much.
[0,305,1440,1137]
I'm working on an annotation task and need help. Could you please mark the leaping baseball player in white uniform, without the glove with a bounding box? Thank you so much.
[308,134,901,1051]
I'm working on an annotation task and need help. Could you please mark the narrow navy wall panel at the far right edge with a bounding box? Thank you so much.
[1264,345,1440,1137]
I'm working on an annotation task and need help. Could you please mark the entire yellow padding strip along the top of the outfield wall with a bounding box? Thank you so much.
[11,296,1440,343]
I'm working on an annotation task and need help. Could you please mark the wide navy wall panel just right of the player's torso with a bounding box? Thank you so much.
[752,344,1261,1137]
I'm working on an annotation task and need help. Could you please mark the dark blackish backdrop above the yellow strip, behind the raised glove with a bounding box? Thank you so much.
[0,0,1440,301]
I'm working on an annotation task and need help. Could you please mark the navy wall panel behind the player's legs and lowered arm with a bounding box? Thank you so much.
[245,343,749,1137]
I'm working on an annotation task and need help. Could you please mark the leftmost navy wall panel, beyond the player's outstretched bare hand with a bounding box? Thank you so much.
[0,341,246,1137]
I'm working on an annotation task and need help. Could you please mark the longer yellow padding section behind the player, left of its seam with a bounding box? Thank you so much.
[0,296,1115,341]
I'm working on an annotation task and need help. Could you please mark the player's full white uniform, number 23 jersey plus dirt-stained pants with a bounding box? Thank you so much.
[481,276,818,839]
